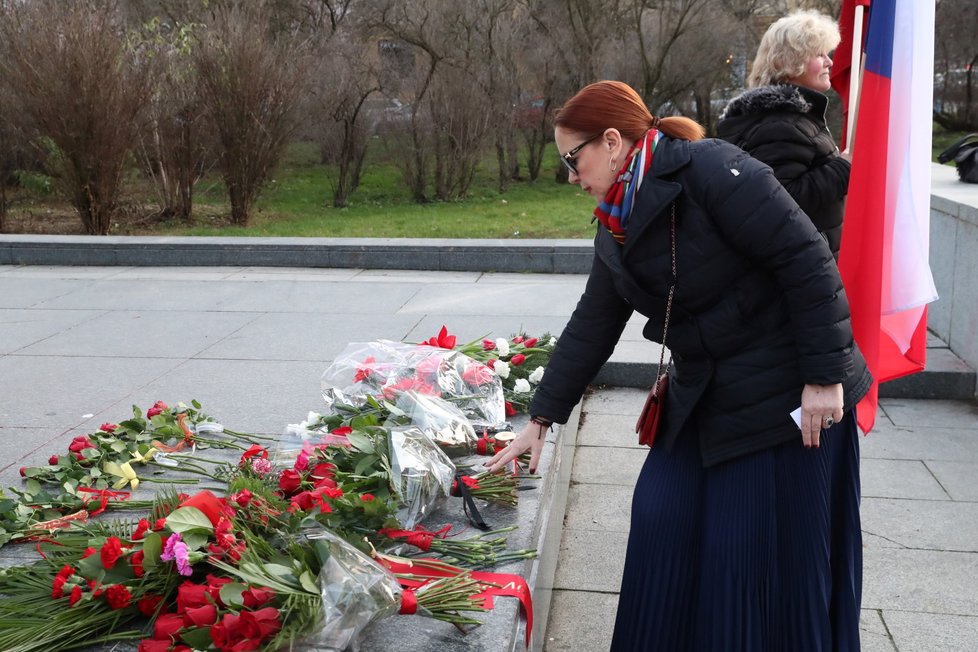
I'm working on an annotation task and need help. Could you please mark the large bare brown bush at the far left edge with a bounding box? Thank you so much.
[0,0,150,235]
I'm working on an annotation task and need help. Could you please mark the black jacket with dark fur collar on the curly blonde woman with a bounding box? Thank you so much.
[717,84,850,260]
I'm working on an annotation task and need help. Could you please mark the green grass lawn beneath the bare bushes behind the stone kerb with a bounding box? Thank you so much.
[4,128,964,239]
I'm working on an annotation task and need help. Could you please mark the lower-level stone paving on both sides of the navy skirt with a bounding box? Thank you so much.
[544,388,978,652]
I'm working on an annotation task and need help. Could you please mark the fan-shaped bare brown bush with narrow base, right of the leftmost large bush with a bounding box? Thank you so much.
[194,7,306,225]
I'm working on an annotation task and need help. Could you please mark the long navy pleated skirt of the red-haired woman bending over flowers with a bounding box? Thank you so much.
[611,412,862,652]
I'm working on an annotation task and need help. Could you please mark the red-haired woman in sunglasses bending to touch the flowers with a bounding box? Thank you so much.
[490,81,871,652]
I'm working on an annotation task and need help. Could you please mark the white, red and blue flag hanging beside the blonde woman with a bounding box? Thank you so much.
[837,0,937,433]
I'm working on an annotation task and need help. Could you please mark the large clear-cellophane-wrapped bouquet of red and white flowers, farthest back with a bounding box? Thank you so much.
[321,340,506,427]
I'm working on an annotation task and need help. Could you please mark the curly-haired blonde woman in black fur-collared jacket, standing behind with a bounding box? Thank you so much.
[717,11,849,260]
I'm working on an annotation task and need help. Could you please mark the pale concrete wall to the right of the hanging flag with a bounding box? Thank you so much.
[927,163,978,376]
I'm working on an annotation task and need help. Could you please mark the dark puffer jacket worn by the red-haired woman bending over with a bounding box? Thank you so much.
[530,138,871,465]
